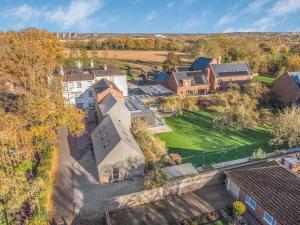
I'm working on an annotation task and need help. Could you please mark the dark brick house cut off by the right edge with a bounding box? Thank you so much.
[271,72,300,105]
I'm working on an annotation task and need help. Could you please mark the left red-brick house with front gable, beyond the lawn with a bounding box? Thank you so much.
[166,71,209,97]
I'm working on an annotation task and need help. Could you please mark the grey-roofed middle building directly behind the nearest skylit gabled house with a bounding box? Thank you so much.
[96,93,132,129]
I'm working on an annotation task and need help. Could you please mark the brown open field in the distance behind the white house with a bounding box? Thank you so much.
[66,50,193,63]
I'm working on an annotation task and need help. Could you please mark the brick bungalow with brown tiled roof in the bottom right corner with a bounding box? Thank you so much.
[225,161,300,225]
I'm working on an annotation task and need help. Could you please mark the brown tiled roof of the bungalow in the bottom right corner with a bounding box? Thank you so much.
[225,163,300,225]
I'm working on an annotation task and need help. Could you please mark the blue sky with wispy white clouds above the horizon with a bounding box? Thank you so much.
[0,0,300,33]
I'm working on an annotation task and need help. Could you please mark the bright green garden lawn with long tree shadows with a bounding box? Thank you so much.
[158,109,272,166]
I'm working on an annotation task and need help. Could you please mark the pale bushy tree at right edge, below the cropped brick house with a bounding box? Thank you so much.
[271,105,300,148]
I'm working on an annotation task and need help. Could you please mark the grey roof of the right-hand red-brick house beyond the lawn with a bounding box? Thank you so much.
[210,63,252,77]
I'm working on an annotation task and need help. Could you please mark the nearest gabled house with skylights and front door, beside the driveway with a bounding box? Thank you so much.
[91,115,145,184]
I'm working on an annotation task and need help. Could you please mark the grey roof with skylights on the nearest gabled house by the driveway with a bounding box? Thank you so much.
[91,115,144,165]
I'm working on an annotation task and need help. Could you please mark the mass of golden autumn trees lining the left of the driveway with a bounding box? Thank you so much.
[0,29,83,224]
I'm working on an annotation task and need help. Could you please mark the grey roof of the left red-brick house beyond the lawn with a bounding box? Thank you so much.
[174,71,208,87]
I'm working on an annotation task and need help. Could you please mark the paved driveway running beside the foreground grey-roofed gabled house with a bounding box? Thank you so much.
[49,125,143,225]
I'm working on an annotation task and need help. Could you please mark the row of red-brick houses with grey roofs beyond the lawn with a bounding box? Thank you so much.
[164,57,253,96]
